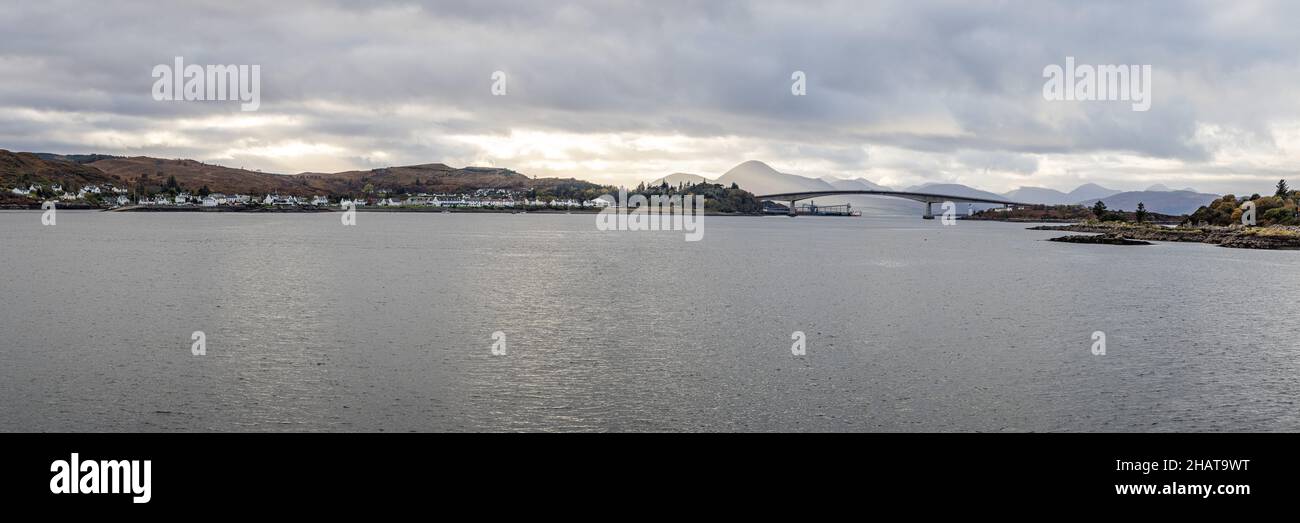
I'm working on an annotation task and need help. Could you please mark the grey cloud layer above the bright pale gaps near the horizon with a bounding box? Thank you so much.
[0,1,1300,189]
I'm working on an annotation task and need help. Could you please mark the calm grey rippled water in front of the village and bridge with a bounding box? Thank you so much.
[0,211,1300,431]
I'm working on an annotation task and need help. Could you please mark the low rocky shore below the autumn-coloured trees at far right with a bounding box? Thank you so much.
[1030,222,1300,248]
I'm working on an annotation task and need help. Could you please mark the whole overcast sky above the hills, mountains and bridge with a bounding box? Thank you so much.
[0,0,1300,193]
